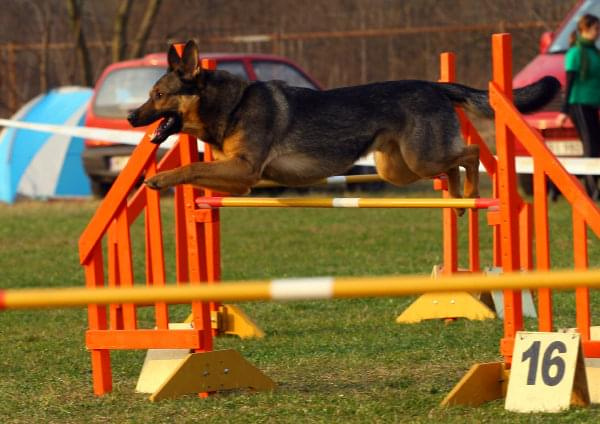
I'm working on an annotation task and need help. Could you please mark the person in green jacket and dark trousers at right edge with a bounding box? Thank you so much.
[558,15,600,200]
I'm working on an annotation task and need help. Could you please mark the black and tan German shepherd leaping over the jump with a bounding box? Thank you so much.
[128,41,560,214]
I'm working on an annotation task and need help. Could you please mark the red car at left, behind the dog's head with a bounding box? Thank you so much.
[83,53,321,196]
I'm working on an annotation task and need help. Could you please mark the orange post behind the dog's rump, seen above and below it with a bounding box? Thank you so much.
[440,52,458,275]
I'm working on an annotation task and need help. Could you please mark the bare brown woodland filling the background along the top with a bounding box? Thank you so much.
[0,0,577,114]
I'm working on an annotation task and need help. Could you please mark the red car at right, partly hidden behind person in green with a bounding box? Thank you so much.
[513,0,600,194]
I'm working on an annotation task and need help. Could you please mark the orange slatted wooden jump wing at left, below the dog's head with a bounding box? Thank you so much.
[79,52,262,395]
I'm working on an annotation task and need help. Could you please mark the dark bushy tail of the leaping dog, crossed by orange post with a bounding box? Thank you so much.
[439,76,560,118]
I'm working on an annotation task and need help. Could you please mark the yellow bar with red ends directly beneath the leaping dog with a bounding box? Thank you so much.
[196,197,497,209]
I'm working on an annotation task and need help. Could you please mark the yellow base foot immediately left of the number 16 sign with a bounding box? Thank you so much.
[441,362,509,406]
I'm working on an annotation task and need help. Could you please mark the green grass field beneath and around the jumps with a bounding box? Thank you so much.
[0,184,600,423]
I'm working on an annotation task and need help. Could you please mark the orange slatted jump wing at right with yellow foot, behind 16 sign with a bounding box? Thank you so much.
[442,34,600,405]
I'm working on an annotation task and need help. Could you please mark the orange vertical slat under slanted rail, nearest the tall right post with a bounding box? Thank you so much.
[533,161,553,331]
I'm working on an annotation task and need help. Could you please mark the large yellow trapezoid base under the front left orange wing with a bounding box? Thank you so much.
[150,350,276,402]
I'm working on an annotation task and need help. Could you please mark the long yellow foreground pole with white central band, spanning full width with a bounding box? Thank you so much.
[0,270,600,310]
